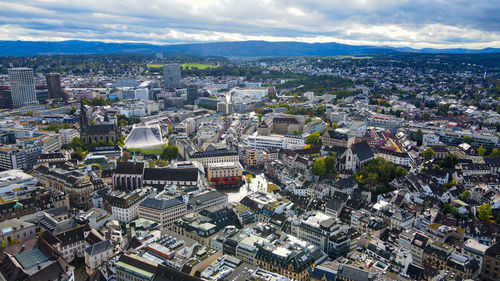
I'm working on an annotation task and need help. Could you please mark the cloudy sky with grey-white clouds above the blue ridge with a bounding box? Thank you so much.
[0,0,500,49]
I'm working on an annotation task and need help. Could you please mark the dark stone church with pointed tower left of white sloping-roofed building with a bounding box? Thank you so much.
[80,103,120,143]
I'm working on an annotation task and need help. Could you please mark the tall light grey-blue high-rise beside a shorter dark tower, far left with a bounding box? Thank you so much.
[8,67,38,108]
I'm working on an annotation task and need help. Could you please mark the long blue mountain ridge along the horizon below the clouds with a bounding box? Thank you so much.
[0,40,500,57]
